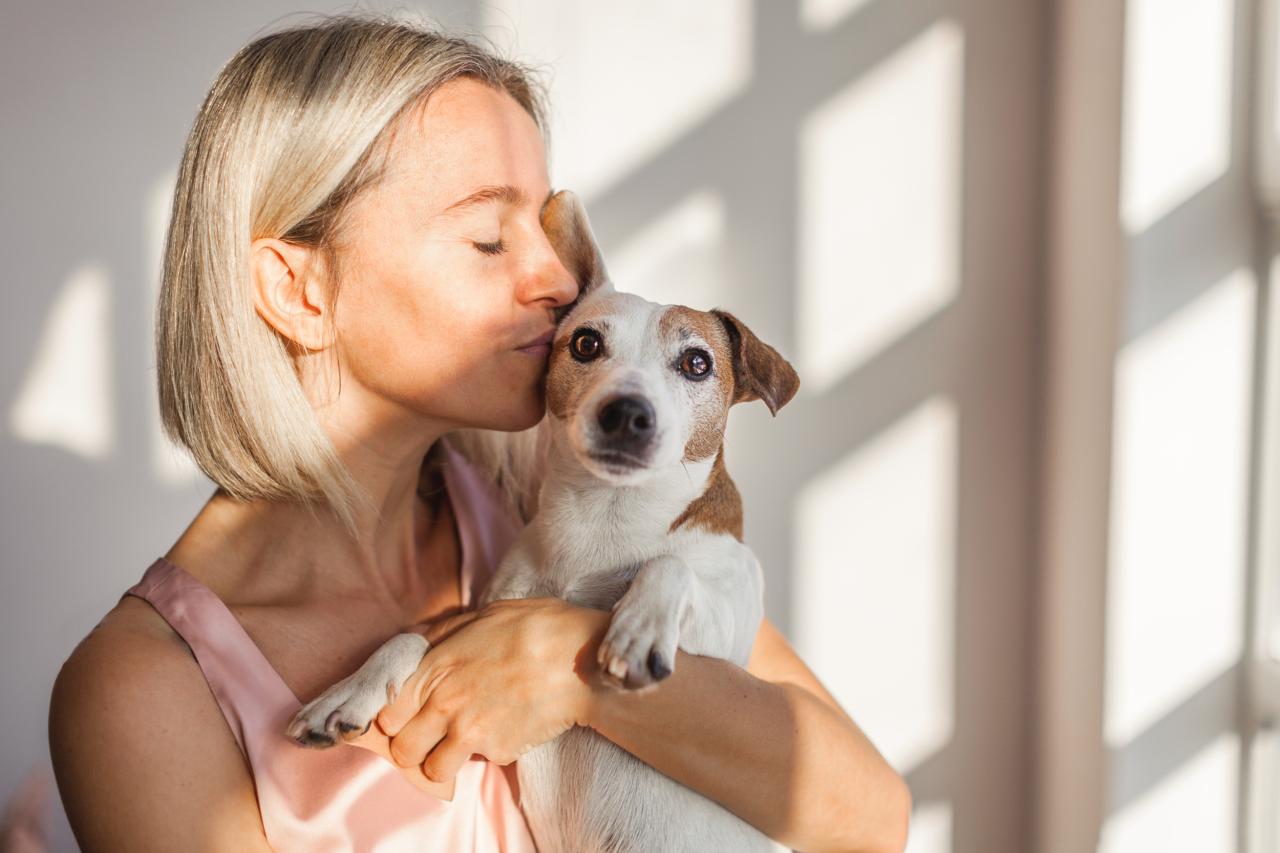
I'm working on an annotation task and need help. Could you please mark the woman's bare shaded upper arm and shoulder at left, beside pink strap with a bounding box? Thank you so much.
[49,598,270,853]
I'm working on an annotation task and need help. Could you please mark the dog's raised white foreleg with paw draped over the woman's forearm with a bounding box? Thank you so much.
[596,555,694,688]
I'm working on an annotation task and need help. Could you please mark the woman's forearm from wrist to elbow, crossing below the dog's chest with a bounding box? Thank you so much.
[570,613,910,853]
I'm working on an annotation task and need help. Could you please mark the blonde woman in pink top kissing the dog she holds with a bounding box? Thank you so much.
[50,17,910,850]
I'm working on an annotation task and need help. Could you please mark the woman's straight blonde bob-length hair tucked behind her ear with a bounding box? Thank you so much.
[155,14,548,535]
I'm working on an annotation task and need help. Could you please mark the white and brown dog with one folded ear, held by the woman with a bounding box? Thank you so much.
[288,191,800,853]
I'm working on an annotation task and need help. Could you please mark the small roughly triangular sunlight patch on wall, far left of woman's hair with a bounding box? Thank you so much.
[9,264,115,460]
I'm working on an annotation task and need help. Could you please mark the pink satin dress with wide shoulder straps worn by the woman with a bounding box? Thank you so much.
[125,442,535,853]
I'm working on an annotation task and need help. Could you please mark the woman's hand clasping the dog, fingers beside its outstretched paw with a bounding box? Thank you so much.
[351,598,609,797]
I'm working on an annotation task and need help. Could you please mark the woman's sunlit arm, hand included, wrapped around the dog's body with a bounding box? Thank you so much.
[368,598,911,853]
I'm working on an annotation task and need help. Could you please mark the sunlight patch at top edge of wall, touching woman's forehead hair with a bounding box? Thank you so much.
[481,0,751,204]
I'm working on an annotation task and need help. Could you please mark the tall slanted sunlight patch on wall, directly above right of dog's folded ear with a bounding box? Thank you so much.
[797,20,964,394]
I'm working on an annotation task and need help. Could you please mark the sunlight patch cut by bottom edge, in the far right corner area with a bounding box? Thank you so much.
[1098,733,1240,853]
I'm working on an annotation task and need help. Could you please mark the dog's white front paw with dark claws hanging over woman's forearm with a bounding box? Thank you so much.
[595,598,680,689]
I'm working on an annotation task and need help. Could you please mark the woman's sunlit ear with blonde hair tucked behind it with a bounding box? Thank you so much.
[248,237,332,351]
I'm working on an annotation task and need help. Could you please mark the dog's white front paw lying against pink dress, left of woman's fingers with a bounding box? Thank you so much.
[285,634,428,749]
